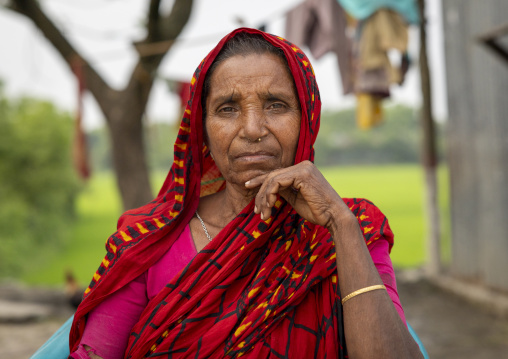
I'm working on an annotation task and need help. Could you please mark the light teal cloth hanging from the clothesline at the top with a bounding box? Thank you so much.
[337,0,420,24]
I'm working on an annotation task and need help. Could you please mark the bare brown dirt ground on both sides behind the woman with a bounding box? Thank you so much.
[0,279,508,359]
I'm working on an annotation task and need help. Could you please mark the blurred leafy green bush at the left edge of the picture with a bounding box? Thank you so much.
[0,88,79,277]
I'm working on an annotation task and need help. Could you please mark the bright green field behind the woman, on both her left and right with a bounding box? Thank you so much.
[22,165,449,285]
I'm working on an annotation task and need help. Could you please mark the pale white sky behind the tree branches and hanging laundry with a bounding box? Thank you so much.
[0,0,447,129]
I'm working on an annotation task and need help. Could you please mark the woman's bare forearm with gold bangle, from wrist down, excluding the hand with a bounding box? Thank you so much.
[328,207,422,358]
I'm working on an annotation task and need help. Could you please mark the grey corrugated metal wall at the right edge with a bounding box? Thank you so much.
[442,0,508,290]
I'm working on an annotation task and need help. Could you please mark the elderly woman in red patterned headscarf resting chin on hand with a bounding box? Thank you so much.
[70,29,420,359]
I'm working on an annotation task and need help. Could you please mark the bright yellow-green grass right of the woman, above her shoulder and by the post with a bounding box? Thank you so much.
[323,165,449,267]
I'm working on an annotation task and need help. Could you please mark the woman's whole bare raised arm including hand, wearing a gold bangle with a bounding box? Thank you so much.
[245,161,422,358]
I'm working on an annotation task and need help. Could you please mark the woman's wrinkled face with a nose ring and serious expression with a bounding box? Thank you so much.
[206,53,301,186]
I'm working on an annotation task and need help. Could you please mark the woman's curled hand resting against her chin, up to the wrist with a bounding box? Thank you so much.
[245,161,351,228]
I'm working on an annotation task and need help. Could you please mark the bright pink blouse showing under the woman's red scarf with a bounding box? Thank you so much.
[70,226,406,359]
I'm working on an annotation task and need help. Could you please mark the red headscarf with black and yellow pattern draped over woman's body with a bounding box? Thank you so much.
[70,28,392,358]
